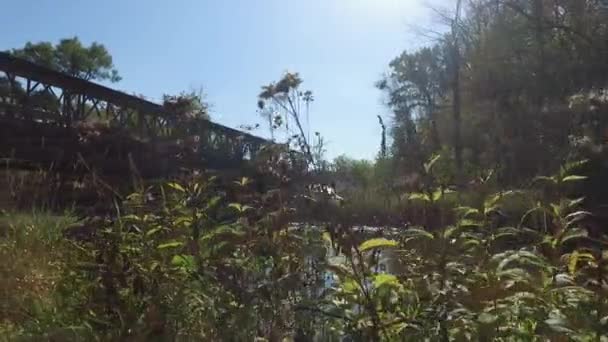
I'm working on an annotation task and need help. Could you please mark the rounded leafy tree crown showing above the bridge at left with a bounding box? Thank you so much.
[10,37,121,82]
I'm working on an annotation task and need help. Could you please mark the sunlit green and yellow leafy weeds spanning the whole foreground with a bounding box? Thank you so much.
[2,156,608,341]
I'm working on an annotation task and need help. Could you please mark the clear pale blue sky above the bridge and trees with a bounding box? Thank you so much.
[0,0,432,159]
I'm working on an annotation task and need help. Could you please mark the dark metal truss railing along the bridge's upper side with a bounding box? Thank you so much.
[0,52,268,164]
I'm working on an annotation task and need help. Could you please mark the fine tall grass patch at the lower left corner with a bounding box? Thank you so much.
[0,210,76,340]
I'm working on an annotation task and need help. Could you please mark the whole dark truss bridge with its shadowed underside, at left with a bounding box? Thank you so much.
[0,53,269,177]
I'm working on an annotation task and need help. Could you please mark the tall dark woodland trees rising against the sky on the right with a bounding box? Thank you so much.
[378,0,608,186]
